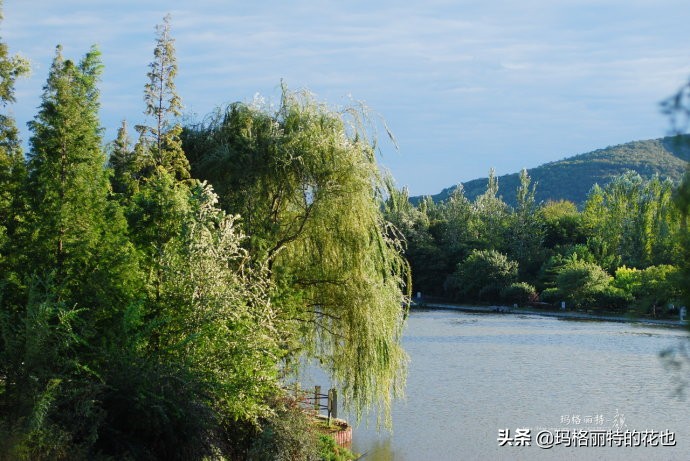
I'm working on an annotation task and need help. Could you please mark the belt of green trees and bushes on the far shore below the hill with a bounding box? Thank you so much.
[385,167,687,317]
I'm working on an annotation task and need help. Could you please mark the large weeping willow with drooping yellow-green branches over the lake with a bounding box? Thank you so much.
[183,90,410,426]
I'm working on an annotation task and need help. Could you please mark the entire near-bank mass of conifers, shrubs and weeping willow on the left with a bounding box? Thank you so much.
[0,12,410,460]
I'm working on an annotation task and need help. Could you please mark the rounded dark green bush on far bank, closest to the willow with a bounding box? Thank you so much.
[446,250,518,301]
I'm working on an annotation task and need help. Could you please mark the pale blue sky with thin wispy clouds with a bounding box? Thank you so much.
[0,0,690,195]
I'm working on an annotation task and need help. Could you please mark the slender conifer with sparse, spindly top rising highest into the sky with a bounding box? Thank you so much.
[129,15,192,310]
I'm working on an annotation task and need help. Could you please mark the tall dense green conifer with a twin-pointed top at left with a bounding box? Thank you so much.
[29,47,138,315]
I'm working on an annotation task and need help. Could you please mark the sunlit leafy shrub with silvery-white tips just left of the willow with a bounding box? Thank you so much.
[155,184,288,420]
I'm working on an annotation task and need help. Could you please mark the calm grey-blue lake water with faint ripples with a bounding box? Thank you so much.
[306,311,690,461]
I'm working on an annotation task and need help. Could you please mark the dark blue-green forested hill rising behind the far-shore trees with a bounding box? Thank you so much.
[420,136,690,206]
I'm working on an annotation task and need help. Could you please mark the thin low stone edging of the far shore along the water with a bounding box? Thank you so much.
[410,302,690,328]
